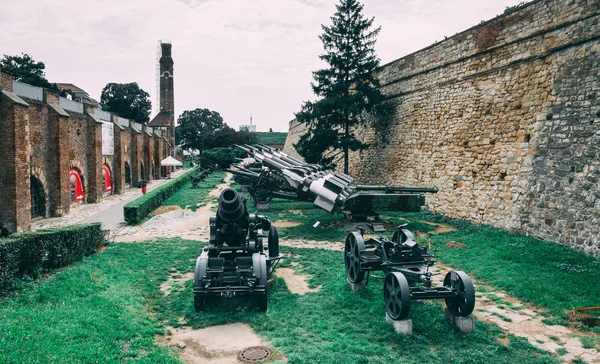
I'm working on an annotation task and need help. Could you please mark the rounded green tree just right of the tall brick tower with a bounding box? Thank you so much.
[175,109,225,153]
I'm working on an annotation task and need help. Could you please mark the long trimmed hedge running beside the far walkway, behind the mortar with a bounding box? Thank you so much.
[123,168,196,224]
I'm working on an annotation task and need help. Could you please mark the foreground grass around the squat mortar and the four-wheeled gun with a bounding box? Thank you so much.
[0,239,557,363]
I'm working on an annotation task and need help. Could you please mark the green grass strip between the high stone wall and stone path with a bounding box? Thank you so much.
[400,213,600,326]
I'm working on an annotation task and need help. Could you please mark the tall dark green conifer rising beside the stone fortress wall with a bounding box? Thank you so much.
[295,0,383,173]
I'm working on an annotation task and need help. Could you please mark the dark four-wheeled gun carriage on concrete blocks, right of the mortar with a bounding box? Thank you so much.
[344,224,475,320]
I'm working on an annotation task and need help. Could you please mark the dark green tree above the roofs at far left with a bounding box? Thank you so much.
[0,53,59,91]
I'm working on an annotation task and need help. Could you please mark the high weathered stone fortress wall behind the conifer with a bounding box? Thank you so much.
[285,0,600,255]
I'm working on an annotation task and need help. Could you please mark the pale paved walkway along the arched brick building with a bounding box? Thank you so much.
[31,169,185,230]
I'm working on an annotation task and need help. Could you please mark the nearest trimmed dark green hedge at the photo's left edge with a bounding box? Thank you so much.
[0,223,104,290]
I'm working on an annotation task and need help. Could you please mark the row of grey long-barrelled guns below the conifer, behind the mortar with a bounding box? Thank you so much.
[228,145,438,219]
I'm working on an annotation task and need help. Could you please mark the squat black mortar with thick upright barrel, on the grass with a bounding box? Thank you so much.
[193,188,282,311]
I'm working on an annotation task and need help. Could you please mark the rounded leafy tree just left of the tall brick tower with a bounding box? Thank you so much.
[100,82,152,124]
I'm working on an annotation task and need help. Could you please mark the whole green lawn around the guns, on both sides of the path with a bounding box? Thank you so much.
[0,173,600,363]
